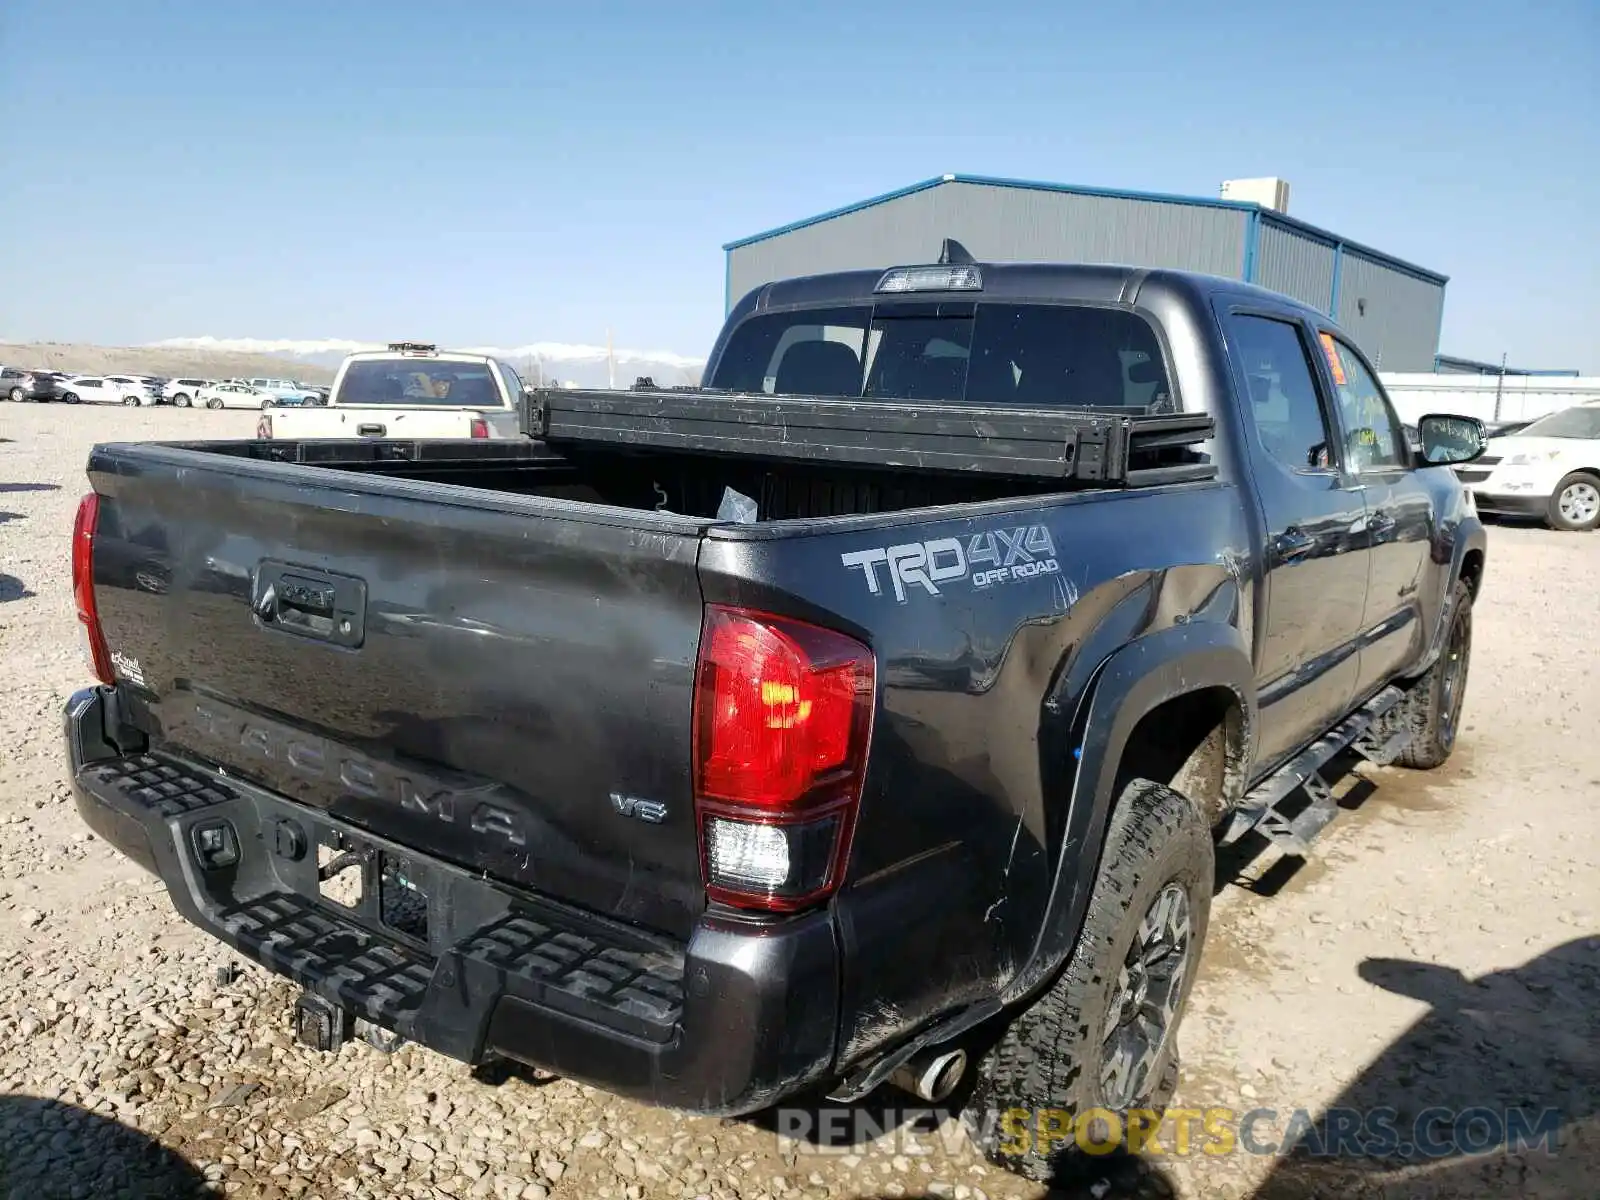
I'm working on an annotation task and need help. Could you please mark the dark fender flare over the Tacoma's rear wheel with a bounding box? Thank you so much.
[1002,621,1256,1003]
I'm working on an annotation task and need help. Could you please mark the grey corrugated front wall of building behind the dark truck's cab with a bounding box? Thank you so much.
[728,182,1248,306]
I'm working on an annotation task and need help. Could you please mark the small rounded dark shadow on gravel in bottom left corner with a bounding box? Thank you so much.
[0,1096,206,1200]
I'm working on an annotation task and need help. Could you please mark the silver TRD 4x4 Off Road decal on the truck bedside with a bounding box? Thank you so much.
[838,525,1061,603]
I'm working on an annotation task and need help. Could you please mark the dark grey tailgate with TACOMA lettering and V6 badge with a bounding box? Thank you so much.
[90,444,704,934]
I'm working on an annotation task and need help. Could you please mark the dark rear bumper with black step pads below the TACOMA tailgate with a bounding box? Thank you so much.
[66,688,838,1115]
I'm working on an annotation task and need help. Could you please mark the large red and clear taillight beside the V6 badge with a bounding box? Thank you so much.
[694,605,875,912]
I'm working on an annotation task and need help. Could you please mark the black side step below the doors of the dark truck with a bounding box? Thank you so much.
[1222,686,1411,858]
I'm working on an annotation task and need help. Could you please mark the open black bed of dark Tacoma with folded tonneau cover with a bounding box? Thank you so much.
[171,392,1216,522]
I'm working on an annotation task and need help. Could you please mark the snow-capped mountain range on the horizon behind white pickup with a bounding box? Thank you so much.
[149,338,706,387]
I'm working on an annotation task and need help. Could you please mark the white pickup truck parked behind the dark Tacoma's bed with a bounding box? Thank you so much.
[256,342,523,438]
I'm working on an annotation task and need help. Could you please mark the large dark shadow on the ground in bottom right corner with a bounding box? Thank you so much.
[1253,936,1600,1200]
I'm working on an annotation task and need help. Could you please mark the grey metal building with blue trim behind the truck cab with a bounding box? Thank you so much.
[723,174,1448,371]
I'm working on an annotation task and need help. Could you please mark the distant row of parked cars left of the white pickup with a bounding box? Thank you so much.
[0,366,328,408]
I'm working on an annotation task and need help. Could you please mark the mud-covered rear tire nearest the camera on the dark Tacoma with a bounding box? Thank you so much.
[962,779,1216,1182]
